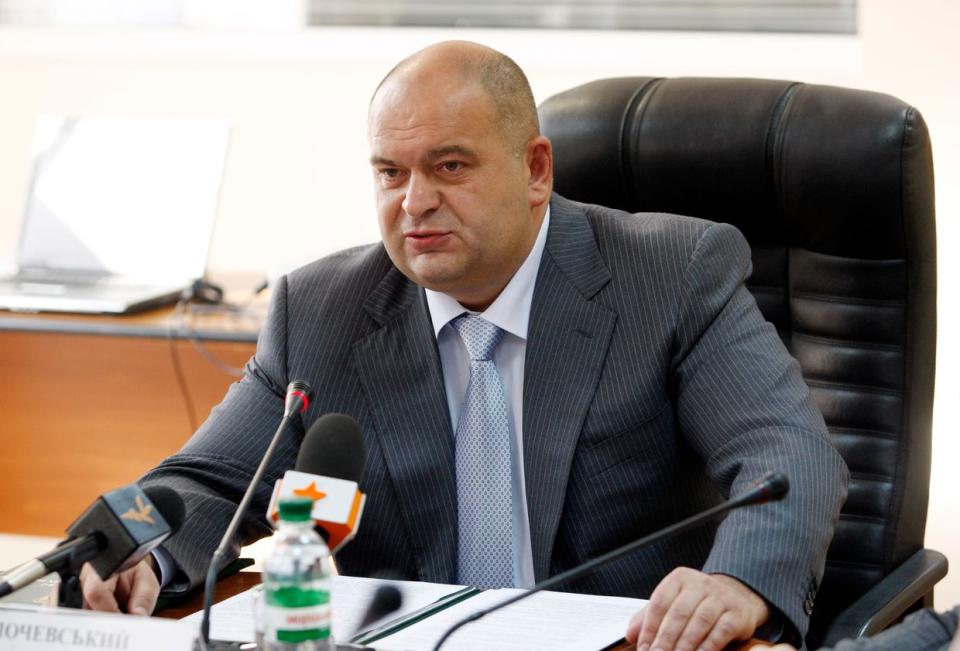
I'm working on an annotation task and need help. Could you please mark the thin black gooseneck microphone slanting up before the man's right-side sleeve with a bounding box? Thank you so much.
[433,472,790,651]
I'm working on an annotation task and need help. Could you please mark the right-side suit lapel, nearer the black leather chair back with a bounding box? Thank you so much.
[523,195,617,581]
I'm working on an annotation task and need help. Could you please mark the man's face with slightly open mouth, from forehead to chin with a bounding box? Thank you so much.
[369,78,542,309]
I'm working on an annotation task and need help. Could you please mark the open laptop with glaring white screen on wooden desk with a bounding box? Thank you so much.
[0,116,230,314]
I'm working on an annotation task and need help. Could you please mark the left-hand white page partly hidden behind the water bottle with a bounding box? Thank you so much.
[184,576,463,642]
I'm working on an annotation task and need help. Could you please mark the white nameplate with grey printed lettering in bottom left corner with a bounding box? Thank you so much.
[0,605,197,651]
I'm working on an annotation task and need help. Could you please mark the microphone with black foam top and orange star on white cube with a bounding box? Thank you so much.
[267,414,367,553]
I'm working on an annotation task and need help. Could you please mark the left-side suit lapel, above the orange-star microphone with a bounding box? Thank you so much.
[354,269,457,583]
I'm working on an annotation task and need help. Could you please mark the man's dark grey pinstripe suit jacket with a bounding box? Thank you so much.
[146,195,847,633]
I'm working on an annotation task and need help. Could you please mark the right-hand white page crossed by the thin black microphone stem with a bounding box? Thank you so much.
[372,589,647,651]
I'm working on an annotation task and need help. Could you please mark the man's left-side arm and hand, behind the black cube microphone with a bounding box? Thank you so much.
[81,279,303,612]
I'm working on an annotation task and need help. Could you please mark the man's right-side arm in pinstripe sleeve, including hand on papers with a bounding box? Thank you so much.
[628,224,848,650]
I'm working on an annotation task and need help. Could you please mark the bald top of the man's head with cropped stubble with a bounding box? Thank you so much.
[370,41,540,153]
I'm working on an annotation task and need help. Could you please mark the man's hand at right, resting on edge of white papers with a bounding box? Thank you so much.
[625,567,770,651]
